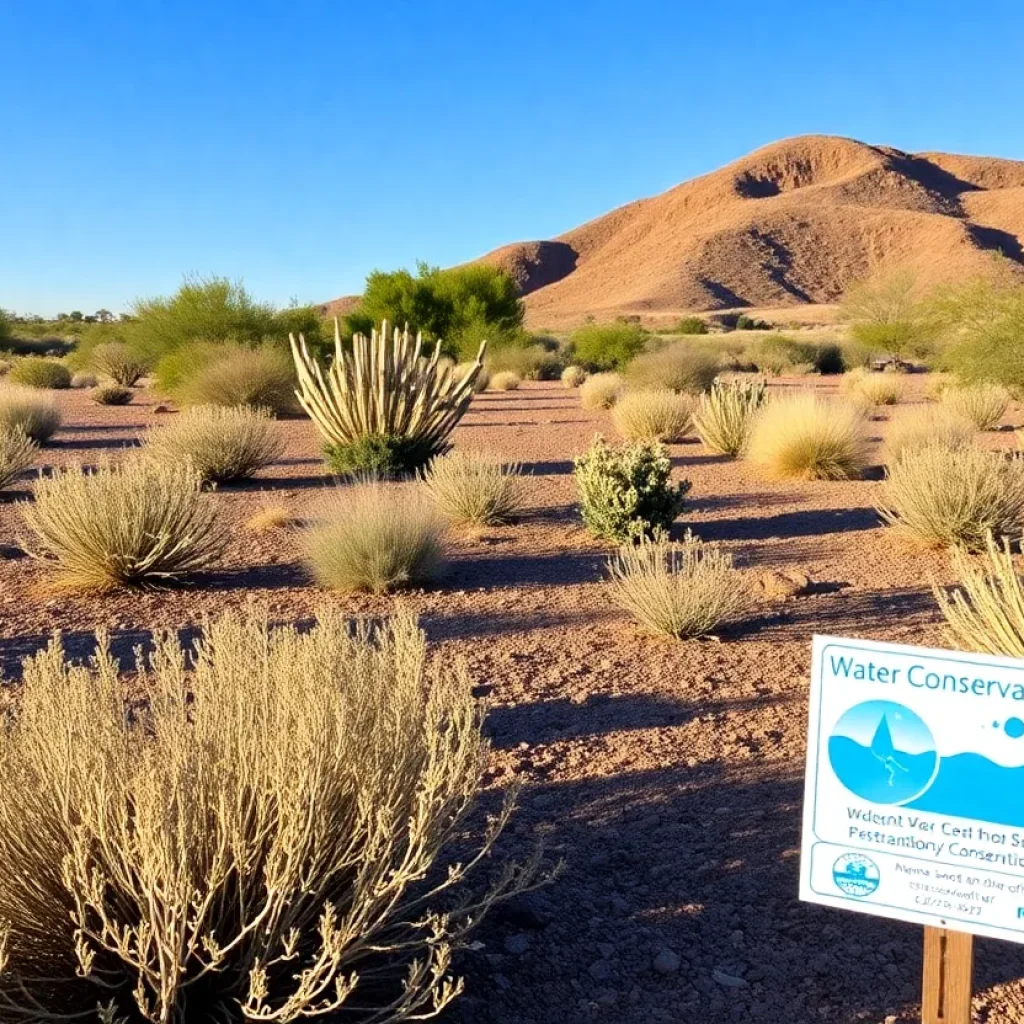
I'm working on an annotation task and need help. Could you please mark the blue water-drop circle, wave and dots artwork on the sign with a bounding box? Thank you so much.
[828,700,1024,827]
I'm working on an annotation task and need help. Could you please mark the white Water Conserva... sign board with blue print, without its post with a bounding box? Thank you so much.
[800,637,1024,942]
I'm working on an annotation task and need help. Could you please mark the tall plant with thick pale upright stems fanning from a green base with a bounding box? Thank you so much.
[289,319,487,474]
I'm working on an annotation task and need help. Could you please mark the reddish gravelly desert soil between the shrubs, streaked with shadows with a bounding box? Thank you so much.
[0,377,1024,1024]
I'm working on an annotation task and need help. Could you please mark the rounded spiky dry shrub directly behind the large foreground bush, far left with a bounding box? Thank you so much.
[22,459,225,590]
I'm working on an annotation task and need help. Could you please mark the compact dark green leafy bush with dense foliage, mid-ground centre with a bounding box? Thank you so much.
[574,435,690,541]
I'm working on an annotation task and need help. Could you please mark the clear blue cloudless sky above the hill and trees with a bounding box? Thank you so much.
[0,0,1024,314]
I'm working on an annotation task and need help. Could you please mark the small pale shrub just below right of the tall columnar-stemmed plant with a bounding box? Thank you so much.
[423,450,525,526]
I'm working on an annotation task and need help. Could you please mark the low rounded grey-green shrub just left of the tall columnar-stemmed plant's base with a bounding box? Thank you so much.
[144,406,284,483]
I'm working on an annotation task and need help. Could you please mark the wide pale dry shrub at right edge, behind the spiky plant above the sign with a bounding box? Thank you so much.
[878,444,1024,550]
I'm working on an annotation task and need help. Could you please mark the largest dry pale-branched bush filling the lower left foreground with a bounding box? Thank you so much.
[0,609,537,1024]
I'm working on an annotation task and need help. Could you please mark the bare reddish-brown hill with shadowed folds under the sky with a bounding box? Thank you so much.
[325,135,1024,328]
